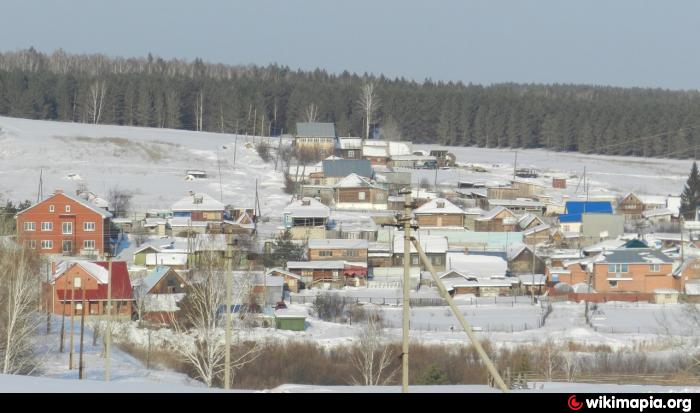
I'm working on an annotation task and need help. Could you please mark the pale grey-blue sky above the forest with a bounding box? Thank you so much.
[0,0,700,89]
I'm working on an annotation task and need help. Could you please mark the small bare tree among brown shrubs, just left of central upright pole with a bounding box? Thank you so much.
[350,312,400,386]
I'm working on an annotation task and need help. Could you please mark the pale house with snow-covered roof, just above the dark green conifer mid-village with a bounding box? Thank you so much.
[282,197,331,240]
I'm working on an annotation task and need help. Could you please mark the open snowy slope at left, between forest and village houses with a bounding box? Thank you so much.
[0,117,289,215]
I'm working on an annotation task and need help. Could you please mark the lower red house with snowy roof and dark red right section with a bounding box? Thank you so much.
[47,260,133,317]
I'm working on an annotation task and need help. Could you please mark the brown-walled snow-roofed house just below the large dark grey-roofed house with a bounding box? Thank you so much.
[335,173,388,210]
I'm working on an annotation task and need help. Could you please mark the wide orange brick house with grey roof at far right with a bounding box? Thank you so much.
[593,247,683,293]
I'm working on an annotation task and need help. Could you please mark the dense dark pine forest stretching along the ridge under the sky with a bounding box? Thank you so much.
[0,48,700,158]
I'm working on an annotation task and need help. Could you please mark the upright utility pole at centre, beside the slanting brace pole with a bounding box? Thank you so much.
[399,188,413,393]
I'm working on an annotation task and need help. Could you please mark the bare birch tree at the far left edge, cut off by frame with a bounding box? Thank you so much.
[0,244,41,374]
